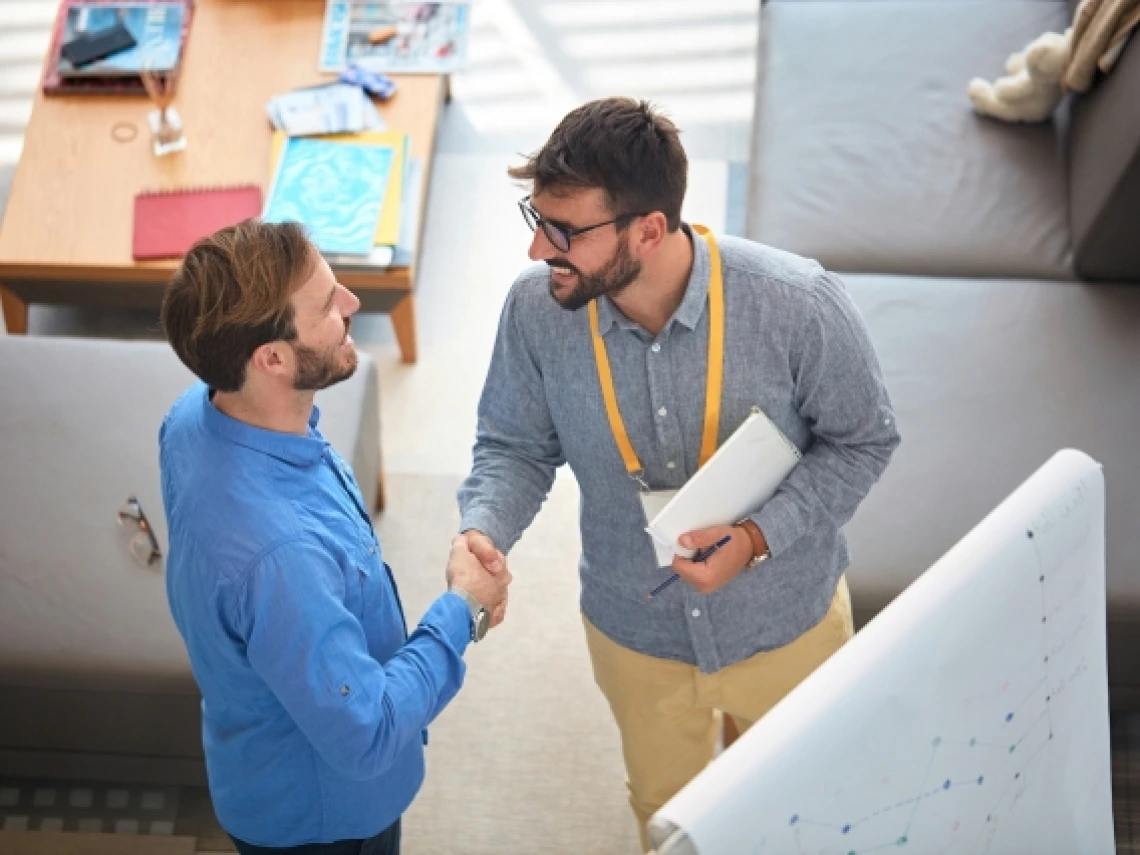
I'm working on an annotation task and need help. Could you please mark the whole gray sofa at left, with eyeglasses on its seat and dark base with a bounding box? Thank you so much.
[0,335,380,784]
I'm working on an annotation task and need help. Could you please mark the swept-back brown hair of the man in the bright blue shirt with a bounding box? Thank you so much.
[162,219,316,392]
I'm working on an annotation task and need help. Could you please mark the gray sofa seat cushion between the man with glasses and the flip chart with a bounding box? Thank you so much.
[844,275,1140,687]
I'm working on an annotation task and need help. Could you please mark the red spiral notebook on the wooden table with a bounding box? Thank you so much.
[131,185,261,261]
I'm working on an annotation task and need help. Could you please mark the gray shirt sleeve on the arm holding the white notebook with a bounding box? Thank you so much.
[751,272,899,556]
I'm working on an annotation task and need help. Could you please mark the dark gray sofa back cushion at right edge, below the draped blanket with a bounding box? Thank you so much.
[1069,27,1140,282]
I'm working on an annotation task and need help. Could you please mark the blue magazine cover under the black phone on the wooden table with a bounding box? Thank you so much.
[59,2,186,78]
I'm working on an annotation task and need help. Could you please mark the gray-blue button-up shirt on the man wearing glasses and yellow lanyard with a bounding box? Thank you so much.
[459,228,899,673]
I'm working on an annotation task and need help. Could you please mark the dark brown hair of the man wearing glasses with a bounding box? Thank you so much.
[507,98,689,231]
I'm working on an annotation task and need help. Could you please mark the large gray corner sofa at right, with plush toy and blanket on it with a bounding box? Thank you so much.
[747,0,1140,707]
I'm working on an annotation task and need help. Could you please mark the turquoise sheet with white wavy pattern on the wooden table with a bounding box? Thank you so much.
[262,137,394,255]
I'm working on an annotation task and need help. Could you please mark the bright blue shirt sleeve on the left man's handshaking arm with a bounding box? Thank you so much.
[238,539,471,780]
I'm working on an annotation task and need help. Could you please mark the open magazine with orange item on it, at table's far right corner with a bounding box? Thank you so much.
[320,0,471,74]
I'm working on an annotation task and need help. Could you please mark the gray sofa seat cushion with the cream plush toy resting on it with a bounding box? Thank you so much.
[748,0,1072,278]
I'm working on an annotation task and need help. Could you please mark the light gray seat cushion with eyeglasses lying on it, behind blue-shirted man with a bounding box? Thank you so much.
[0,336,380,693]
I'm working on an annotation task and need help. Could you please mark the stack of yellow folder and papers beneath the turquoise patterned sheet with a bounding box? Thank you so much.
[267,131,412,264]
